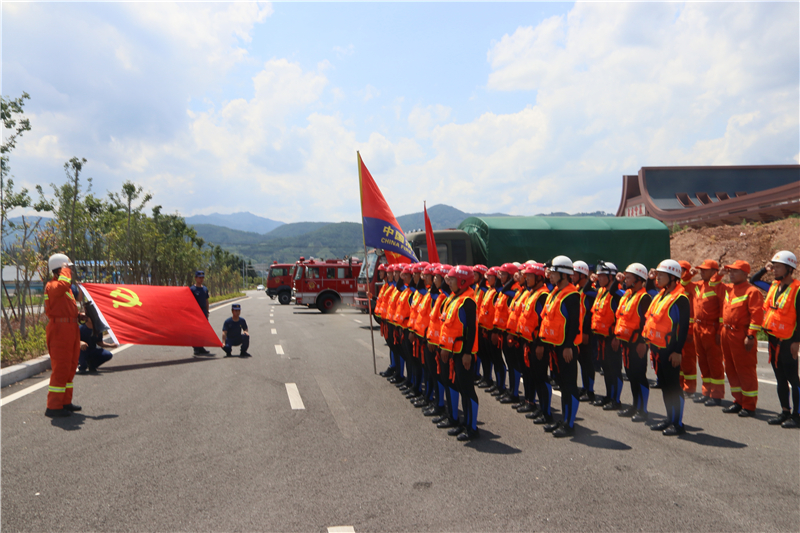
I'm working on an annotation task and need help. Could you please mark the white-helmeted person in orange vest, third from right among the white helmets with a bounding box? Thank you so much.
[612,263,653,422]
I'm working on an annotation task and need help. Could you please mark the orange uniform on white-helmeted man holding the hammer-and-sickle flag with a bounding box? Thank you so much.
[44,267,81,409]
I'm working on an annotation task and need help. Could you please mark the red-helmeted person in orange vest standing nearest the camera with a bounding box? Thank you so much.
[440,265,478,441]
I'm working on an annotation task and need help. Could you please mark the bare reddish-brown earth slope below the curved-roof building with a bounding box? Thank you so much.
[670,218,800,272]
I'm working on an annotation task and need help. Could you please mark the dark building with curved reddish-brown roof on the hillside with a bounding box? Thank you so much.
[617,165,800,226]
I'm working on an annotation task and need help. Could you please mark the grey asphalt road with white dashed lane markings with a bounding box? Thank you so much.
[0,293,800,532]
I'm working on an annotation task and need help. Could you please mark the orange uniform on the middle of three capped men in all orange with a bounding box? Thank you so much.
[687,274,725,399]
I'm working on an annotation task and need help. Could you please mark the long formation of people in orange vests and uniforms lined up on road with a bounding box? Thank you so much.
[374,251,800,441]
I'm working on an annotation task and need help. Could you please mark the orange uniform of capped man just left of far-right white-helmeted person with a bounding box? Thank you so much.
[720,281,764,411]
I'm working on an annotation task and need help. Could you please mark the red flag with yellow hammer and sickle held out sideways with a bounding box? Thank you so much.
[81,283,222,347]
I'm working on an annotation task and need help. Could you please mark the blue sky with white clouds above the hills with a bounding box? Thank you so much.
[2,2,800,222]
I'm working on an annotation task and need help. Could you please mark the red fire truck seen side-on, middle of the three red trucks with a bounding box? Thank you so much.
[294,257,361,313]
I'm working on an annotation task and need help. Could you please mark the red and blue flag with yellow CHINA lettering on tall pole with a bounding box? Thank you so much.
[356,152,417,263]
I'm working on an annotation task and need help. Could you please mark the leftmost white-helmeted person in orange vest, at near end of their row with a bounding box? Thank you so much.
[536,255,583,437]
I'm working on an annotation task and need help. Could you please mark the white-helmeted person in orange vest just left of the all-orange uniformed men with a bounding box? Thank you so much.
[642,259,689,436]
